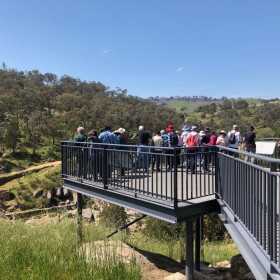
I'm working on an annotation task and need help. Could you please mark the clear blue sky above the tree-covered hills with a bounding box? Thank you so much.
[0,0,280,98]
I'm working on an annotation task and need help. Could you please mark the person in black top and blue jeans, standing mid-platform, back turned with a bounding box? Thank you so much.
[132,125,151,171]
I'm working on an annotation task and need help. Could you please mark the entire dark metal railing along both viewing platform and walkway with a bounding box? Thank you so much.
[62,141,280,274]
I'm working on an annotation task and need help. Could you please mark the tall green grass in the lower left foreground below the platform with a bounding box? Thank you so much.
[0,219,141,280]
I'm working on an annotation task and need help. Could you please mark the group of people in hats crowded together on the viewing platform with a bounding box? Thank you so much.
[74,124,256,175]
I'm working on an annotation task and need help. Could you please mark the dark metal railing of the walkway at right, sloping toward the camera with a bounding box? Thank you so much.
[216,149,280,271]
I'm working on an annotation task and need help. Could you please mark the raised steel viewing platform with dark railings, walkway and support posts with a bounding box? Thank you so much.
[62,141,280,280]
